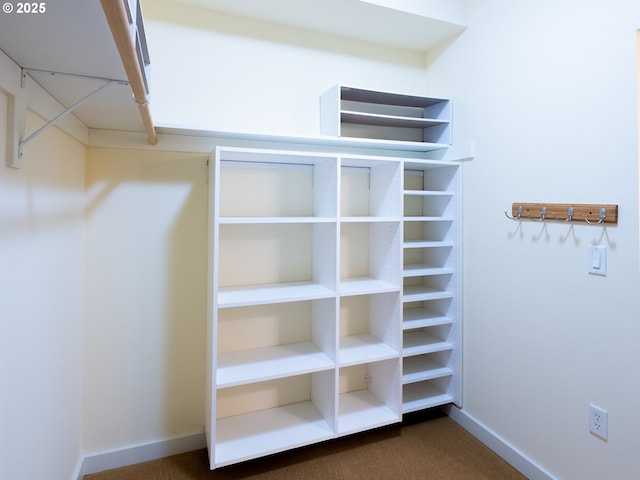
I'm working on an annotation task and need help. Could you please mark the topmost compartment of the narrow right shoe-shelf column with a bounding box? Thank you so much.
[404,160,460,195]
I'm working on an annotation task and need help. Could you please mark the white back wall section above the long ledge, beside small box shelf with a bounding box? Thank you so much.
[143,0,425,135]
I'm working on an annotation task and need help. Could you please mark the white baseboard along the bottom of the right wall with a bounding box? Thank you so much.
[447,407,556,480]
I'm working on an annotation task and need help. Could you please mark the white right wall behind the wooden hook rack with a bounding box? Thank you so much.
[427,0,640,480]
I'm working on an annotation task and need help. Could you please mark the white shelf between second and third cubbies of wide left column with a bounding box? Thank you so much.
[218,282,335,308]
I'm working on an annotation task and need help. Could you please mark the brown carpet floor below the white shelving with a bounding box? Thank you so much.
[85,414,526,480]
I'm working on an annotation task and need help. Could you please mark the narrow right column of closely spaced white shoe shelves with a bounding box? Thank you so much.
[402,160,461,413]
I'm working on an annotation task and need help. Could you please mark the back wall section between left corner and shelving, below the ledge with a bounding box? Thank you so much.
[83,148,207,454]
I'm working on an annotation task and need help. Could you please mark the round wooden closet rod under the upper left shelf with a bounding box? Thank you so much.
[100,0,158,145]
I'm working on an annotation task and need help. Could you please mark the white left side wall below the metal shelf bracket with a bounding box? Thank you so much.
[0,96,85,480]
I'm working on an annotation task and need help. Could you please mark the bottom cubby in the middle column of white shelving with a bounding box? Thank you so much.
[338,358,402,435]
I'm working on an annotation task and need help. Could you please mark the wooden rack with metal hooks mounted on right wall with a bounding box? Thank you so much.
[505,202,618,224]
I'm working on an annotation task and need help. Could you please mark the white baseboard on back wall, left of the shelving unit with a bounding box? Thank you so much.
[74,432,207,480]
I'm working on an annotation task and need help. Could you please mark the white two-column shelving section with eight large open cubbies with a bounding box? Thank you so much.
[206,147,403,468]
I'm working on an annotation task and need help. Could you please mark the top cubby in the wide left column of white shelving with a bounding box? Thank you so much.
[215,147,337,222]
